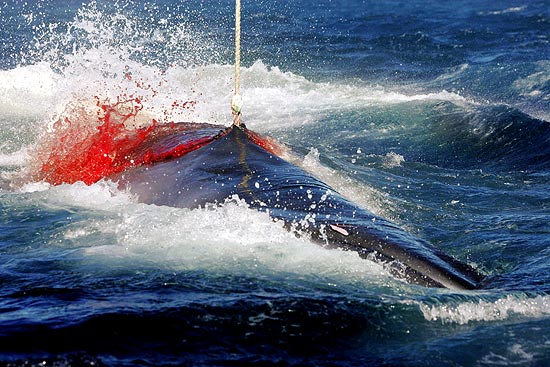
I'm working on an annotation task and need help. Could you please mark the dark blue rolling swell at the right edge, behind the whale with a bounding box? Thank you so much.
[324,100,550,171]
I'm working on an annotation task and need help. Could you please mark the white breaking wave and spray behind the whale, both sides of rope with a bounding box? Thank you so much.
[0,1,508,157]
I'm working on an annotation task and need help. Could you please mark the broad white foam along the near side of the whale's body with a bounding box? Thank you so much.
[21,181,388,287]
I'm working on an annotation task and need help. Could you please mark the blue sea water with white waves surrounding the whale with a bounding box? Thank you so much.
[0,0,550,366]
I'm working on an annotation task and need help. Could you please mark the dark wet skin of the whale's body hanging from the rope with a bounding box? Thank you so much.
[109,124,482,289]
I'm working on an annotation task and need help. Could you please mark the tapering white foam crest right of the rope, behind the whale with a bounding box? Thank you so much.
[237,61,466,129]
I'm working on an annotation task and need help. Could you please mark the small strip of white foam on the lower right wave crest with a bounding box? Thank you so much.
[420,295,550,325]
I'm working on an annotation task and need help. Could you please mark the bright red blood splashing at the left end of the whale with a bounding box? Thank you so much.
[31,97,214,185]
